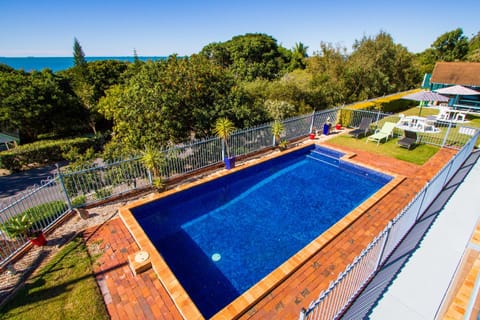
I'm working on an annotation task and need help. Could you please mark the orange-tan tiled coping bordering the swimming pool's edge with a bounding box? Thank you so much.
[119,141,405,319]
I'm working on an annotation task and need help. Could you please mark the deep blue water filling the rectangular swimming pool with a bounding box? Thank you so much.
[132,146,391,317]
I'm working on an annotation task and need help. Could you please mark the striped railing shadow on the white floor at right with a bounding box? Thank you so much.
[341,151,480,319]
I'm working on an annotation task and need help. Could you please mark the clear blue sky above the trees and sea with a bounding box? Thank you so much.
[0,0,480,57]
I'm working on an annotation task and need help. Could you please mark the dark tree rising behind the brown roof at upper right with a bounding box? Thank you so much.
[432,28,468,62]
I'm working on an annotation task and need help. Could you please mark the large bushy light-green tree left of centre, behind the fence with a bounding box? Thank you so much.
[99,55,249,154]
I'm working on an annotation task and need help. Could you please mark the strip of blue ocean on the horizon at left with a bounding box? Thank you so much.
[0,56,166,72]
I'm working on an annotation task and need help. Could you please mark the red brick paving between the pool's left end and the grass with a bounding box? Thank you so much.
[83,218,181,319]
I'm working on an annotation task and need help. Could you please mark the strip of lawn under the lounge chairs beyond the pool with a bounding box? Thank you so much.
[328,134,440,165]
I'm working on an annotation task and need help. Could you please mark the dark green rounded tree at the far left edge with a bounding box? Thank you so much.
[0,69,85,142]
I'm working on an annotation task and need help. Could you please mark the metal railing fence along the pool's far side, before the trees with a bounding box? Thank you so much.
[0,106,478,267]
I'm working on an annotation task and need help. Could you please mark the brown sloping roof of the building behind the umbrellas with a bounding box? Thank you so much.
[430,62,480,87]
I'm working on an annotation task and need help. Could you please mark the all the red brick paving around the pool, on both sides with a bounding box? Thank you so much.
[80,143,455,319]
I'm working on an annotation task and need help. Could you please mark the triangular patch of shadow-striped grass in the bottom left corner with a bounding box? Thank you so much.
[0,237,109,320]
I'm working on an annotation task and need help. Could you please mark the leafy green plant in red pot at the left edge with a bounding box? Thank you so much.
[0,214,47,246]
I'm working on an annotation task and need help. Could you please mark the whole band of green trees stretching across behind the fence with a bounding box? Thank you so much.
[0,28,480,151]
